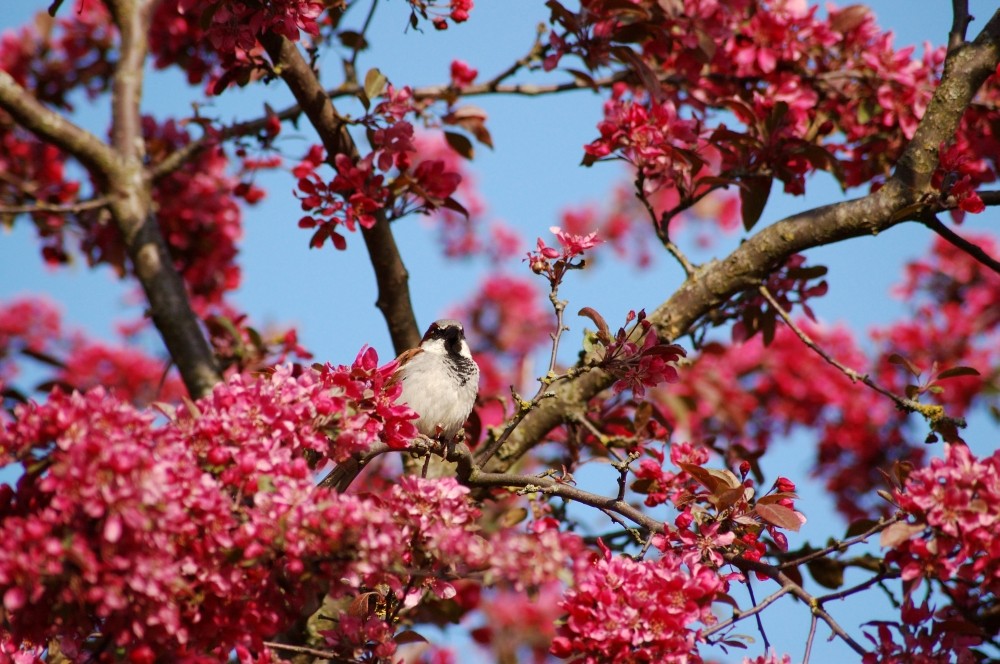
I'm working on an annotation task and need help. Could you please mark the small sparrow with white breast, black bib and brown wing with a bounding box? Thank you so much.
[320,318,479,492]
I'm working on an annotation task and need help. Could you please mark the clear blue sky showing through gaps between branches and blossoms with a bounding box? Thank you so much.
[0,0,998,662]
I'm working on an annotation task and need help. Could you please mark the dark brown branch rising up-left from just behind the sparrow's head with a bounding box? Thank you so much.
[262,34,420,353]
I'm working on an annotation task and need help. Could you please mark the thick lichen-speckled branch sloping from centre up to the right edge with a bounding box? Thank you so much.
[487,11,1000,471]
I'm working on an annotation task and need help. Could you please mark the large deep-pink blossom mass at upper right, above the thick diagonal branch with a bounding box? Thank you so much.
[544,0,1000,226]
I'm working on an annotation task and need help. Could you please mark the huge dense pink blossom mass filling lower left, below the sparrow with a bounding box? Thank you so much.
[0,349,426,656]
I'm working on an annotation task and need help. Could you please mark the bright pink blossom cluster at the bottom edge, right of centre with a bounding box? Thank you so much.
[551,547,723,664]
